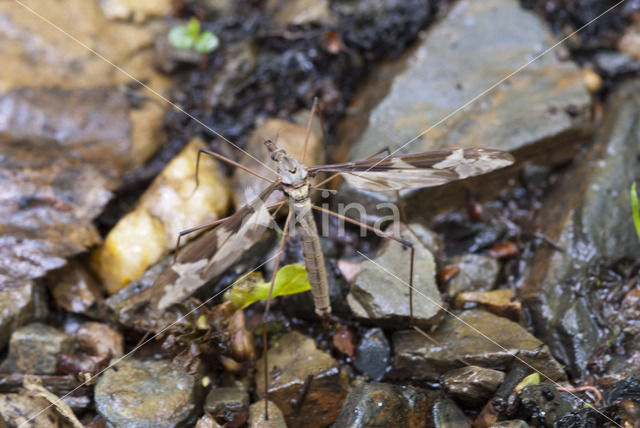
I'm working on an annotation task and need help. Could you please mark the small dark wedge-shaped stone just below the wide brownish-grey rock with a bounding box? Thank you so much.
[442,366,504,407]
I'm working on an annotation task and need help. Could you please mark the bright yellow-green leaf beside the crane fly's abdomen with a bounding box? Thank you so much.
[224,263,311,309]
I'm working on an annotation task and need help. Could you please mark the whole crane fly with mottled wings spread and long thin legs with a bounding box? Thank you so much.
[146,103,513,418]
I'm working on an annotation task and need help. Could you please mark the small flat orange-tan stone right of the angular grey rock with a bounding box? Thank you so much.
[453,288,522,322]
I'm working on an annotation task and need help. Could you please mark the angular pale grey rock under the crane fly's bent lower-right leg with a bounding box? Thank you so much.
[347,223,442,326]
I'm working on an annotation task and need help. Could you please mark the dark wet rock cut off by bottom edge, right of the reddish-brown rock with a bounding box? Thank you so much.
[333,383,437,428]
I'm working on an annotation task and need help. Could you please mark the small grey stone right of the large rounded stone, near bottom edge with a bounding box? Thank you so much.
[204,386,249,428]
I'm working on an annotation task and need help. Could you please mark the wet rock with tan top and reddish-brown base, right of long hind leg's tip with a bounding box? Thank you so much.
[255,332,349,427]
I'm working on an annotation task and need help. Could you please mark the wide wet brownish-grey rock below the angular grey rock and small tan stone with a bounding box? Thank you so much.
[387,310,566,380]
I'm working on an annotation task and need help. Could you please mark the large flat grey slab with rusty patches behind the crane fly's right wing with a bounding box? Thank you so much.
[338,0,591,220]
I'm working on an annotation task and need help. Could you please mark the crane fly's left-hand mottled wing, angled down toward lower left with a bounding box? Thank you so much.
[150,183,277,310]
